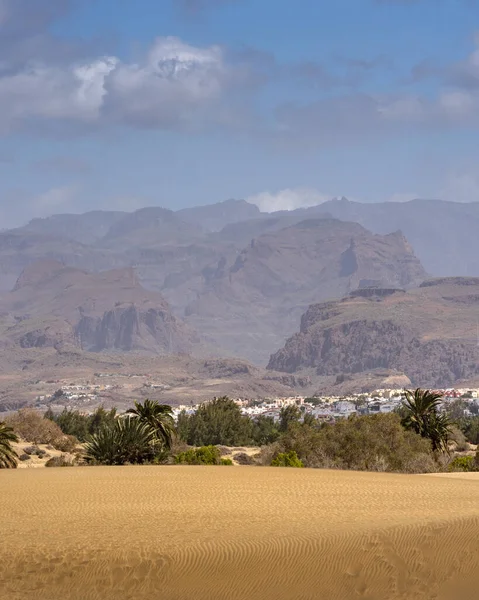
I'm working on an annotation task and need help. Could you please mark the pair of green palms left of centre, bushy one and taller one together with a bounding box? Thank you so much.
[85,400,175,465]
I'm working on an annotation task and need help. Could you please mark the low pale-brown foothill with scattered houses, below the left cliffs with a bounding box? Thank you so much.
[0,347,304,415]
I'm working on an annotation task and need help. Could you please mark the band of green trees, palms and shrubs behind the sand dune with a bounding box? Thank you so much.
[0,389,479,473]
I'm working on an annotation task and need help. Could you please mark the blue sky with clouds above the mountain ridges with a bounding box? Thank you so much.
[0,0,479,227]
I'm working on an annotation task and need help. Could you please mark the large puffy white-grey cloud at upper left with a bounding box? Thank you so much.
[0,37,234,132]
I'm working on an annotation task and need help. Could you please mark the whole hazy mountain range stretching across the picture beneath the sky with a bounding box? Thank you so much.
[0,198,479,396]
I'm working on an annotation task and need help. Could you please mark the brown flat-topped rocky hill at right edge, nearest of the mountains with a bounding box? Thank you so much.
[268,280,479,386]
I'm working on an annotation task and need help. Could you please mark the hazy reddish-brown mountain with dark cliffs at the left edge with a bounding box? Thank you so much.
[0,260,199,354]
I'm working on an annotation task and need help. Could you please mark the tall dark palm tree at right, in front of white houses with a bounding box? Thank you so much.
[402,388,450,450]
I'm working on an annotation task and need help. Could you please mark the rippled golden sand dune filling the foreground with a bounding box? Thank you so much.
[0,467,479,600]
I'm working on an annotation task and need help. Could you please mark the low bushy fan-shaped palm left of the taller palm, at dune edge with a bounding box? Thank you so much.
[85,417,157,465]
